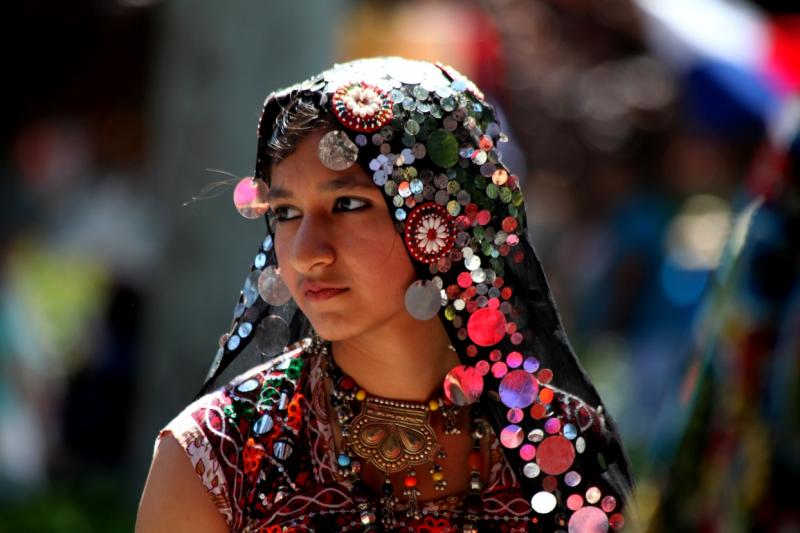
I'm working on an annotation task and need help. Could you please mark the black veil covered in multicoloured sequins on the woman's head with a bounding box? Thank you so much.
[198,58,631,529]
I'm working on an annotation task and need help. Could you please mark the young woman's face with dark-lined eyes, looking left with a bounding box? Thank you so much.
[269,129,416,340]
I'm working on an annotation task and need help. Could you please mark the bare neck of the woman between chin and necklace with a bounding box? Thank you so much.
[331,317,459,401]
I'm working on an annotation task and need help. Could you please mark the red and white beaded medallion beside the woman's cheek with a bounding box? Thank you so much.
[405,202,455,263]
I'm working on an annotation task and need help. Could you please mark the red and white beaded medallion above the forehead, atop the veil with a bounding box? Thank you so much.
[331,81,392,133]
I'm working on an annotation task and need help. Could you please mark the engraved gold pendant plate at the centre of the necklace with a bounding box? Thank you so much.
[349,398,440,474]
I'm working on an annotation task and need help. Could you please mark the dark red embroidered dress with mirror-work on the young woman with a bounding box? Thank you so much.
[161,338,621,532]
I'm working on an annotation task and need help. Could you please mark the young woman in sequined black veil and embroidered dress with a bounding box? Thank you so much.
[137,58,631,532]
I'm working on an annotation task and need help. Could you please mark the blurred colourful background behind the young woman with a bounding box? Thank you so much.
[0,0,800,532]
